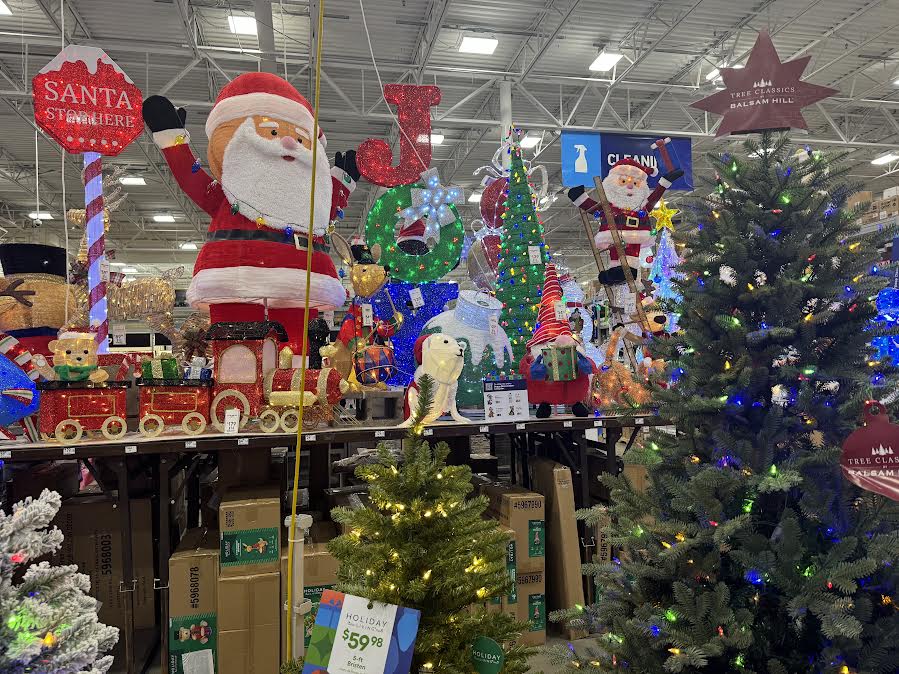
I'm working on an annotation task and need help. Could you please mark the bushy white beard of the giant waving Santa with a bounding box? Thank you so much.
[221,118,331,235]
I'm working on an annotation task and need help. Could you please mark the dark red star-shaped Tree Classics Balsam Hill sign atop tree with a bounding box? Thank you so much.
[692,32,837,136]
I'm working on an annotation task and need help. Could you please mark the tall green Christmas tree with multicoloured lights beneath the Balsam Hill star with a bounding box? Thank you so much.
[557,134,899,674]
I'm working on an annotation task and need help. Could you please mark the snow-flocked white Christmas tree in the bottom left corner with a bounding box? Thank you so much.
[0,489,119,674]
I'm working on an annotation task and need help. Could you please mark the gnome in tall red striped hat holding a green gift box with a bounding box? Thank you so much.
[518,264,596,419]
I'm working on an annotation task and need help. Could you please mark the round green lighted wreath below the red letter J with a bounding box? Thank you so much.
[365,185,465,283]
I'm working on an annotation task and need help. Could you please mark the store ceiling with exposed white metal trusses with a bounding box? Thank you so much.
[0,0,899,278]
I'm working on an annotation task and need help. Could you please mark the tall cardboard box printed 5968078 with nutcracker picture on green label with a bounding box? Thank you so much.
[168,529,219,674]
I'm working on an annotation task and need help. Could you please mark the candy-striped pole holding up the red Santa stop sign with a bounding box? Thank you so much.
[84,152,109,353]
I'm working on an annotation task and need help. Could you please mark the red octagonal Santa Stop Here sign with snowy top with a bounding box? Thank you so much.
[31,45,144,157]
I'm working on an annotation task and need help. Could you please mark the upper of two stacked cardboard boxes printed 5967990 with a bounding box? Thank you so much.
[480,482,546,573]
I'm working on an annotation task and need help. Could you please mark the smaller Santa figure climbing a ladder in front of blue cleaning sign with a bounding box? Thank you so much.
[568,158,684,285]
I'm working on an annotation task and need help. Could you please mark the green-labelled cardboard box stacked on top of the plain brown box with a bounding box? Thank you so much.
[219,487,281,576]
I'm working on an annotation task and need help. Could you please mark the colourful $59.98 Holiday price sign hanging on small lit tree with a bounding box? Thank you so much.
[303,590,421,674]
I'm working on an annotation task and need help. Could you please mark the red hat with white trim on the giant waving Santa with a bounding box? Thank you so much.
[206,72,327,147]
